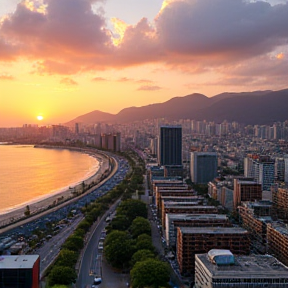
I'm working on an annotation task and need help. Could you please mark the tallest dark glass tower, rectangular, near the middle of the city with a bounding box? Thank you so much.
[158,126,182,166]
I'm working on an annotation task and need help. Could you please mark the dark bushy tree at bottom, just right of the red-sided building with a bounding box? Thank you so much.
[48,265,77,286]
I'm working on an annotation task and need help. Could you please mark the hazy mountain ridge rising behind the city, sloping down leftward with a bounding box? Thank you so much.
[66,89,288,126]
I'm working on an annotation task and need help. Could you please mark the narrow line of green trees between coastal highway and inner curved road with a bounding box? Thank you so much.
[48,151,147,287]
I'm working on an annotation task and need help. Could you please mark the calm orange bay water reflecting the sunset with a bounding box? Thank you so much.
[0,145,99,215]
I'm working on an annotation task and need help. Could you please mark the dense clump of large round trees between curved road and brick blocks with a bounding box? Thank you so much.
[104,199,170,288]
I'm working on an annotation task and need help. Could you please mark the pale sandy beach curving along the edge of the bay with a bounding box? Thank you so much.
[0,147,109,228]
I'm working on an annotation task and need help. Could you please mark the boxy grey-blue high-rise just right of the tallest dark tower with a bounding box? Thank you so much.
[190,152,217,184]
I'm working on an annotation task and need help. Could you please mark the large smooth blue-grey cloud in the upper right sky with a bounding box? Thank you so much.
[156,0,288,65]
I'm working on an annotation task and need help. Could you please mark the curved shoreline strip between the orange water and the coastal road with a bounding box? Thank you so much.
[0,145,109,228]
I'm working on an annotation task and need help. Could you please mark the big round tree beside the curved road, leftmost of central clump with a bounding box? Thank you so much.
[104,230,135,268]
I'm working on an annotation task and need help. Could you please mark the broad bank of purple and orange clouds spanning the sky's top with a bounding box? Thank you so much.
[0,0,288,80]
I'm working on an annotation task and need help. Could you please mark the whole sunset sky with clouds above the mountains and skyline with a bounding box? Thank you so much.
[0,0,288,127]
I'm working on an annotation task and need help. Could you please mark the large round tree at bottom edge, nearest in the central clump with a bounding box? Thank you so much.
[130,259,169,288]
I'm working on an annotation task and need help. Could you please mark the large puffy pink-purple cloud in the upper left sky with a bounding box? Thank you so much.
[0,0,113,74]
